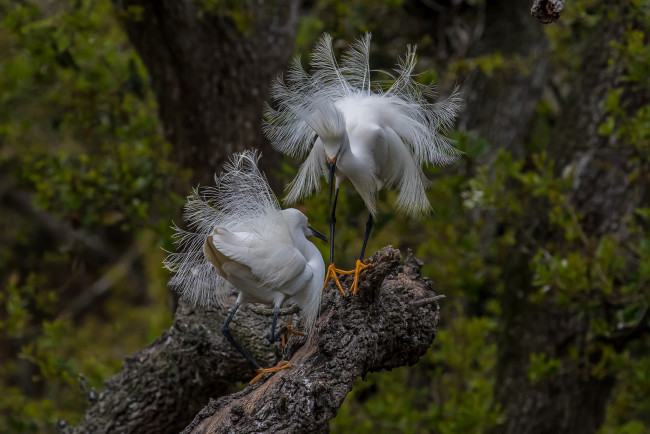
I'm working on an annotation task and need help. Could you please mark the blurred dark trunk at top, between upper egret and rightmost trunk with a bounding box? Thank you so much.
[459,0,549,161]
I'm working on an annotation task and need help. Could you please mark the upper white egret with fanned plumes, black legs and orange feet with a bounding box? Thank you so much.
[265,34,460,295]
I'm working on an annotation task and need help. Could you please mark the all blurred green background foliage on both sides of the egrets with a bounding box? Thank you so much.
[0,0,650,434]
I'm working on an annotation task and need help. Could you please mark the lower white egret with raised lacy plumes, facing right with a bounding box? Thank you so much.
[165,152,327,383]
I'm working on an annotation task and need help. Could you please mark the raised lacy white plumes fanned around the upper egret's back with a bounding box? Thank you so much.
[265,33,461,170]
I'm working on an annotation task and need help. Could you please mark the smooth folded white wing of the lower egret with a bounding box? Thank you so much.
[212,227,307,289]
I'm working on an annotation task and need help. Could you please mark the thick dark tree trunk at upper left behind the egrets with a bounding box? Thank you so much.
[114,0,299,184]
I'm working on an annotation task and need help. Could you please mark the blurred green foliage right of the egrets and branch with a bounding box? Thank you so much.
[332,2,650,432]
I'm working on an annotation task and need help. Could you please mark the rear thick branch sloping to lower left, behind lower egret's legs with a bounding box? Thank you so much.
[62,302,279,433]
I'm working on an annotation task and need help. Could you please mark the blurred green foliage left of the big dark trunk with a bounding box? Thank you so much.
[0,0,178,432]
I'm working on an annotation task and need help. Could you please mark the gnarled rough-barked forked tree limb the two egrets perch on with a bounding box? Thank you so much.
[62,247,439,433]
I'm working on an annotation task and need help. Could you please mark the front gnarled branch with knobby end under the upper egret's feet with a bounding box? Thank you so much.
[184,247,438,434]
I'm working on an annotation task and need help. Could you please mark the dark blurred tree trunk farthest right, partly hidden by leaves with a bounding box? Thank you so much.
[495,0,647,434]
